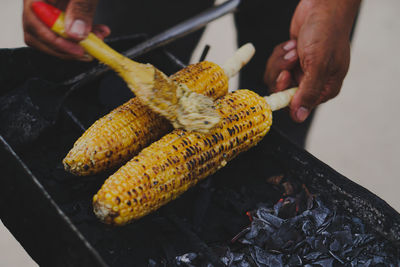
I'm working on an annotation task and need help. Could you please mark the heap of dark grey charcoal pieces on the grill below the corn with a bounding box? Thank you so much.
[176,197,400,267]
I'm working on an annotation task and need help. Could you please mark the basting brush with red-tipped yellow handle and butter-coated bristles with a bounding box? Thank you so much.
[32,2,220,132]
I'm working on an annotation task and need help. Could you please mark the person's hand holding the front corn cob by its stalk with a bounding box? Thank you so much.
[264,0,360,122]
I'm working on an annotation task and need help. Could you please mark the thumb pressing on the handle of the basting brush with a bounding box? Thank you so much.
[65,0,97,41]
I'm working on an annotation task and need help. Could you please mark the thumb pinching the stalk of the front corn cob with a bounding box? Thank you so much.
[290,69,324,122]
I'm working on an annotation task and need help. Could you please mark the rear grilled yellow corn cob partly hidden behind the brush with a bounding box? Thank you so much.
[63,61,228,175]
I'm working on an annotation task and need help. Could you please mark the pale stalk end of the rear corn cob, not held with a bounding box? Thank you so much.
[222,43,256,78]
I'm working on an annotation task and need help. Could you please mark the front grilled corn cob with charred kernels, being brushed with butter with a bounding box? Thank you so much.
[93,90,272,225]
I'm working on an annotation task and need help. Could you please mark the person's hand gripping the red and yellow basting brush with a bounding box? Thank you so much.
[23,0,110,61]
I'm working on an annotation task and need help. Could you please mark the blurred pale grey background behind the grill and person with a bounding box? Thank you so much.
[0,0,400,267]
